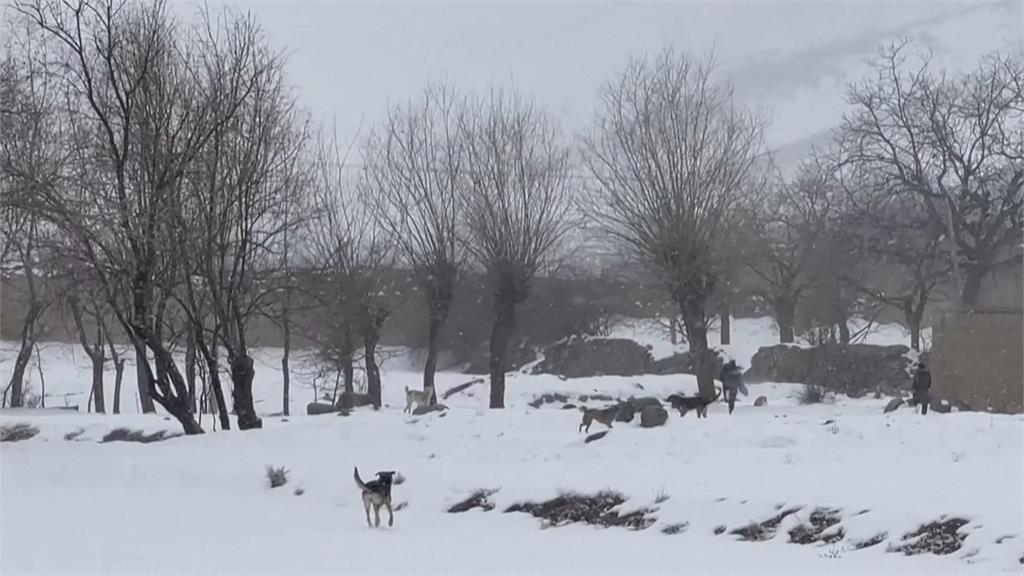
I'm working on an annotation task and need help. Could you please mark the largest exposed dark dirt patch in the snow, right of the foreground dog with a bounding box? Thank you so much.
[505,492,657,530]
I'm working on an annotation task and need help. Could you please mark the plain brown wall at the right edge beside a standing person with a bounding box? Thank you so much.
[931,308,1024,413]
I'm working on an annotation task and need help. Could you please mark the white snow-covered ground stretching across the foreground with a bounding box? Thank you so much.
[0,320,1024,574]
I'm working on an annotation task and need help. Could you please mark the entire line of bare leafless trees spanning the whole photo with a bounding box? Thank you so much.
[0,0,1024,434]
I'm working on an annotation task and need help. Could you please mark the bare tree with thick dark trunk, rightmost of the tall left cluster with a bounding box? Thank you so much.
[173,11,305,429]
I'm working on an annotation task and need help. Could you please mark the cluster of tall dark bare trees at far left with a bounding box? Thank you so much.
[0,0,306,434]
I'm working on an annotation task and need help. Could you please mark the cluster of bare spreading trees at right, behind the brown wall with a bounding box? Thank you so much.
[733,41,1024,349]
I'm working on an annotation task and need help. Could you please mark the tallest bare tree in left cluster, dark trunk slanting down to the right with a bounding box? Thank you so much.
[15,0,286,434]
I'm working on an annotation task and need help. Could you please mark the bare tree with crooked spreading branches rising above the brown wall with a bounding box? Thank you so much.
[841,41,1024,306]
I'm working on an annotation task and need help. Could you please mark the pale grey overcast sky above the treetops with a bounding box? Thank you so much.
[192,0,1024,152]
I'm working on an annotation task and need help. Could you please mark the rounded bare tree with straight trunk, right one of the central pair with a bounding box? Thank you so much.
[460,87,573,408]
